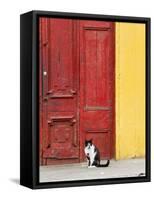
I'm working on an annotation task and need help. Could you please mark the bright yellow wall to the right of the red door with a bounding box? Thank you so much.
[116,23,145,159]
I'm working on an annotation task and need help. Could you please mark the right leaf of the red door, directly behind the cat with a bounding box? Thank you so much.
[80,20,114,159]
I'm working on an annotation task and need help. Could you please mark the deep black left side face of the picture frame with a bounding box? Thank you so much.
[20,12,33,187]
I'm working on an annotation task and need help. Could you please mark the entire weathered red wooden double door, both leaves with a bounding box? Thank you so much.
[39,18,114,164]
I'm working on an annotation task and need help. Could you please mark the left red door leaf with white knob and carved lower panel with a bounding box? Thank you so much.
[40,18,79,164]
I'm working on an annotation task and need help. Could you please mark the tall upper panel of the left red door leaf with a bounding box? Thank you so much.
[48,19,74,98]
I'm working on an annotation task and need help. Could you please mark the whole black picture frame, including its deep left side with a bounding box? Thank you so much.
[20,11,151,189]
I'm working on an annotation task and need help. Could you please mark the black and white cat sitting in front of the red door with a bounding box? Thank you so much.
[84,140,110,167]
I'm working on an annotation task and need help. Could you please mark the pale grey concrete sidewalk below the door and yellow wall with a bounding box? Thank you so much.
[40,158,145,182]
